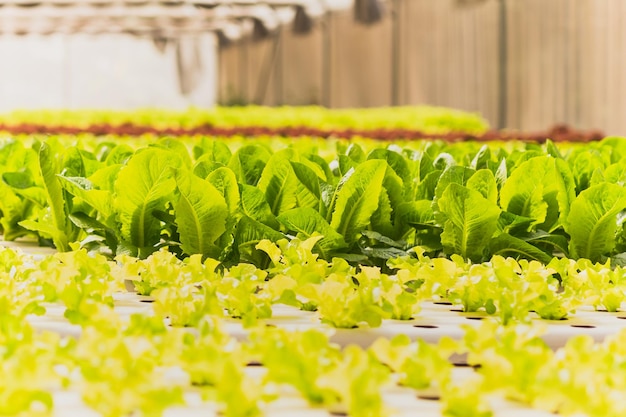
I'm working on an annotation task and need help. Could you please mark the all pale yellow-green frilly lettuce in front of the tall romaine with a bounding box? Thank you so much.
[0,244,626,417]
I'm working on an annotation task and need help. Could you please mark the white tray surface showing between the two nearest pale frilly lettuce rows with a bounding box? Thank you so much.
[8,236,626,349]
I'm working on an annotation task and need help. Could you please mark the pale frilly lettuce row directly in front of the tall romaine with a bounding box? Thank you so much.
[2,231,626,329]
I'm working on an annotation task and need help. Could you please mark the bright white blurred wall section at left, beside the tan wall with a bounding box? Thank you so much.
[0,34,216,111]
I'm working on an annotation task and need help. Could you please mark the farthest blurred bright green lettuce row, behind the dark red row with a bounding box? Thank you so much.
[0,106,488,134]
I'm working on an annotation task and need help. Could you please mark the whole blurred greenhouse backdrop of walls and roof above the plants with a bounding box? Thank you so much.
[0,0,626,134]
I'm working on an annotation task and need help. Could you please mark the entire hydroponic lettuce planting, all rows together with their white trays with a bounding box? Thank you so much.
[0,107,626,417]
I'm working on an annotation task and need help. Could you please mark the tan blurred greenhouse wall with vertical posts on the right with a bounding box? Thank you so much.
[219,0,626,134]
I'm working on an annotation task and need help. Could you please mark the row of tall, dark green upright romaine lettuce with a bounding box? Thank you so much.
[0,137,626,267]
